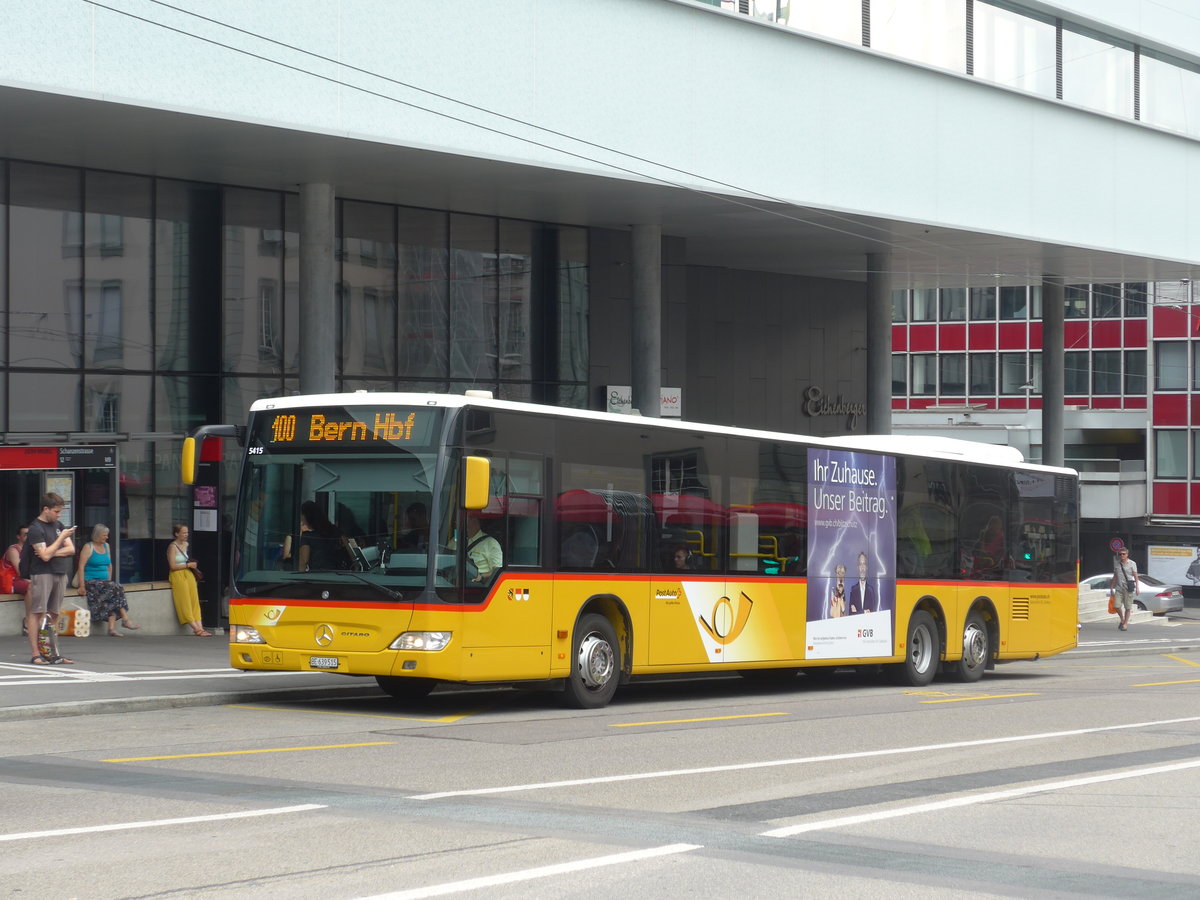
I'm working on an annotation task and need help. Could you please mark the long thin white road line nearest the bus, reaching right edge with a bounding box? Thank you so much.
[407,715,1200,800]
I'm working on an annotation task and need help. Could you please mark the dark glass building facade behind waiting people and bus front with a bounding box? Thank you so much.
[0,160,588,581]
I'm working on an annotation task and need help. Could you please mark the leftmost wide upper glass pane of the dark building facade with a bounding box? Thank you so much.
[8,162,84,369]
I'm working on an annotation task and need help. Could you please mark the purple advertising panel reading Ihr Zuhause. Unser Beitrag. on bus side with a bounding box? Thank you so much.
[805,448,896,659]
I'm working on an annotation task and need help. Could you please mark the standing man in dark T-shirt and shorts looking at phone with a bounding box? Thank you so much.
[25,493,74,666]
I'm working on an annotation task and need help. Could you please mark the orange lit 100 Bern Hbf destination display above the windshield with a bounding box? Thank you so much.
[248,407,442,455]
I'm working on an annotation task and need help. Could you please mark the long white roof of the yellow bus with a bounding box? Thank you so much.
[250,390,1078,475]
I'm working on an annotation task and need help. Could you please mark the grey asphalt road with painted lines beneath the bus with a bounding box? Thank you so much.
[0,622,1200,900]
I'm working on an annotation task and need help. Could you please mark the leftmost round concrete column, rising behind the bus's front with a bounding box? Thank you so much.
[300,185,337,394]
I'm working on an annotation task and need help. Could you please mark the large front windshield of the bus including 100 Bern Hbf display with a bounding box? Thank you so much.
[234,408,456,601]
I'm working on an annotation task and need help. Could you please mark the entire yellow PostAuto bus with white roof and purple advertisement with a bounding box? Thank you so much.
[182,392,1079,708]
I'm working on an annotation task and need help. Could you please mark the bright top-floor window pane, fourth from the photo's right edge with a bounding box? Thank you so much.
[871,0,967,72]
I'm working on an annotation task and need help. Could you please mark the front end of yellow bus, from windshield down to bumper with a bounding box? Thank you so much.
[229,397,475,689]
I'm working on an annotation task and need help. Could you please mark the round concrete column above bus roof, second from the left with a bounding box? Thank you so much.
[630,224,662,419]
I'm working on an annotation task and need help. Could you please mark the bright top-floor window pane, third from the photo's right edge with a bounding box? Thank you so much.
[973,1,1057,97]
